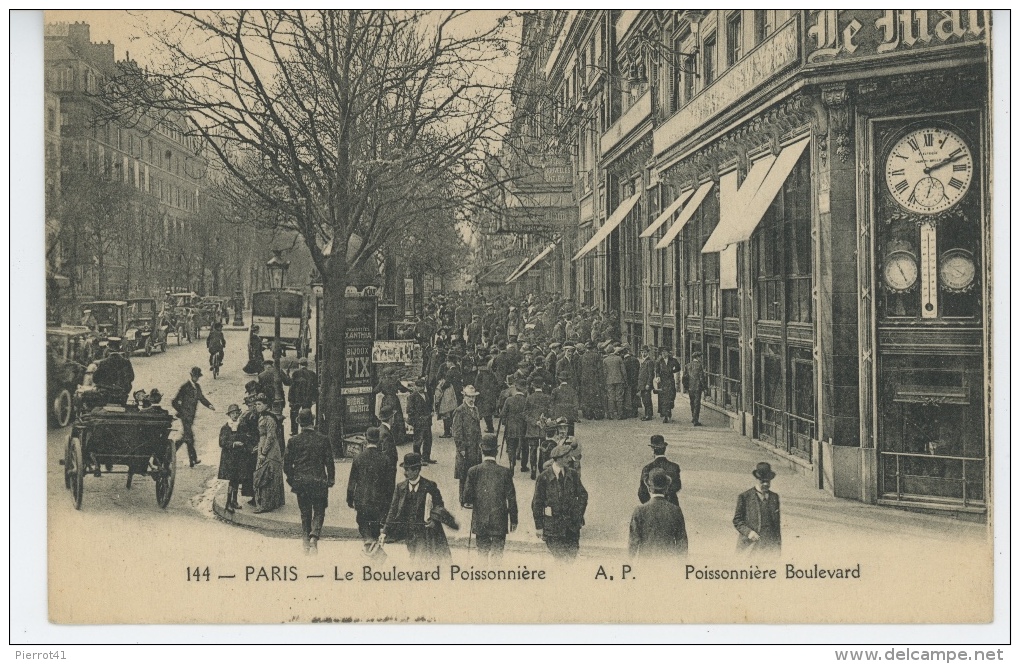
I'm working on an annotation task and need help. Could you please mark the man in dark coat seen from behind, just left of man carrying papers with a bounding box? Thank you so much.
[347,426,397,551]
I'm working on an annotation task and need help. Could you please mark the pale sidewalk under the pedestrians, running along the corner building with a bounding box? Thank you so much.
[213,399,988,555]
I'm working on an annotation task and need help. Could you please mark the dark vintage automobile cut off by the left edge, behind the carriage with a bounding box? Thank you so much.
[46,325,96,426]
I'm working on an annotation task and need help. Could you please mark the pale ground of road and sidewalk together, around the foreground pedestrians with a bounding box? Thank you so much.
[48,329,986,558]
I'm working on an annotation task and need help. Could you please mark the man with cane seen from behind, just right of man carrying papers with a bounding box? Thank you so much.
[464,433,517,562]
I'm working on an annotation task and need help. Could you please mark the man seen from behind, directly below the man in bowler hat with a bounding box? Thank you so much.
[629,468,687,558]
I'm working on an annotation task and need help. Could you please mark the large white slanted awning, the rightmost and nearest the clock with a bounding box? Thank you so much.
[702,138,811,254]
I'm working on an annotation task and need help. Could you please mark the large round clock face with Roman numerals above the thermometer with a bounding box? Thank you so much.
[885,126,974,214]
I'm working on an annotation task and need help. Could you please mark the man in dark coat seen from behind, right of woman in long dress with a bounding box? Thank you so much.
[284,410,336,554]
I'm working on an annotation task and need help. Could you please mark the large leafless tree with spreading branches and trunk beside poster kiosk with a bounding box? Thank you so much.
[107,10,518,441]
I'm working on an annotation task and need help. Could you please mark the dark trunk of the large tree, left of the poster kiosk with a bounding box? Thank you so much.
[319,259,347,452]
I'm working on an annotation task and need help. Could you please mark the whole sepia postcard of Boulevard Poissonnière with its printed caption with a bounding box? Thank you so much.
[35,9,1008,628]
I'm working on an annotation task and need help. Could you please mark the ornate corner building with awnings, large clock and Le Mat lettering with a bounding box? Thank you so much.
[489,10,991,513]
